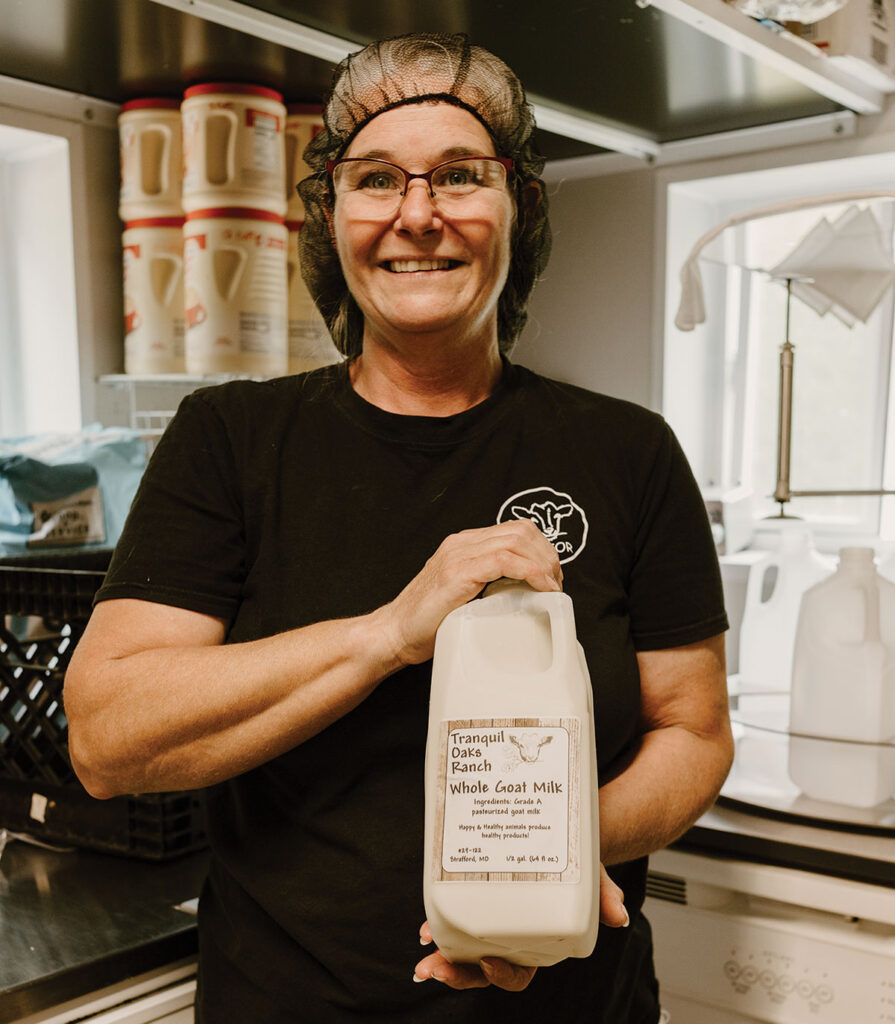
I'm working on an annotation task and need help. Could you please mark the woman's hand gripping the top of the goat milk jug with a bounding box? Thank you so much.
[382,519,562,665]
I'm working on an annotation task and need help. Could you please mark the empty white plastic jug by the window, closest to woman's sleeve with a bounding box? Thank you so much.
[739,519,833,692]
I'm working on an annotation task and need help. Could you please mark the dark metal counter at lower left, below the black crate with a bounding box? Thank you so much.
[0,841,207,1024]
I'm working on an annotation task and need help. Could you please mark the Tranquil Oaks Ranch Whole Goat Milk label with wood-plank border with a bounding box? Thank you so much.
[432,718,581,882]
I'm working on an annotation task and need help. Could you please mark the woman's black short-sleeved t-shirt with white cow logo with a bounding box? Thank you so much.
[97,364,727,1024]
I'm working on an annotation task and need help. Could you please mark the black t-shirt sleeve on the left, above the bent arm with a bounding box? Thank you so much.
[95,391,246,620]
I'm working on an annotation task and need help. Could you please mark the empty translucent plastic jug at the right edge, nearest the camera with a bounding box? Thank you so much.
[790,548,895,807]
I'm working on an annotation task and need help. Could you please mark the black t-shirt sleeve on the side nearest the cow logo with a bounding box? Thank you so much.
[629,423,728,650]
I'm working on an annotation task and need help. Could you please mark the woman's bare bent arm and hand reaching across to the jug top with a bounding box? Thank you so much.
[65,520,561,797]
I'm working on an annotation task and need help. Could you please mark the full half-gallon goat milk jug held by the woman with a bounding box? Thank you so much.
[423,580,600,966]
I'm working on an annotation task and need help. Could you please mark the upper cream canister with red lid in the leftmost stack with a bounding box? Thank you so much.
[118,97,183,222]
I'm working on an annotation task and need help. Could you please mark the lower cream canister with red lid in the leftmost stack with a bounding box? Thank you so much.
[122,216,186,376]
